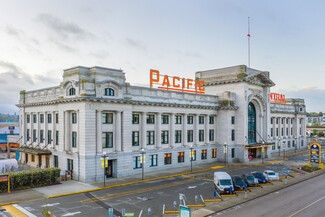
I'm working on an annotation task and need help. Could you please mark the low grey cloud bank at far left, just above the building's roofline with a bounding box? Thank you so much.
[0,60,60,113]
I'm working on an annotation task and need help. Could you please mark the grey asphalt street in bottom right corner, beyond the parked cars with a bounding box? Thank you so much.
[212,174,325,217]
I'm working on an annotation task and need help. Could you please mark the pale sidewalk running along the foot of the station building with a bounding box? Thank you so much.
[0,153,304,206]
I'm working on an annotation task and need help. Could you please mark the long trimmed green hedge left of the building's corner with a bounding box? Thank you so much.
[0,168,60,192]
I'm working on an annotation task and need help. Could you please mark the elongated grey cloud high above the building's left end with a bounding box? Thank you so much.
[37,13,94,39]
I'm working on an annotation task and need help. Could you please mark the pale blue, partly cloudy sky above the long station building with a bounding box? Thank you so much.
[0,0,325,114]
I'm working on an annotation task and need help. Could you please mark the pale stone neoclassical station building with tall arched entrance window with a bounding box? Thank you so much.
[17,65,306,182]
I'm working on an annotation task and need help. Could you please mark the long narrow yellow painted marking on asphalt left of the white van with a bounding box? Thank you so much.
[80,179,197,203]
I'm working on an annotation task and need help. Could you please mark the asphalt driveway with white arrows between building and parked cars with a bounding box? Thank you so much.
[5,164,294,217]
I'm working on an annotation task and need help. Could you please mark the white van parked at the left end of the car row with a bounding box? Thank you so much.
[214,172,235,194]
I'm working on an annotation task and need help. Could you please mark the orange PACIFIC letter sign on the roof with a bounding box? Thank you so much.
[150,69,205,94]
